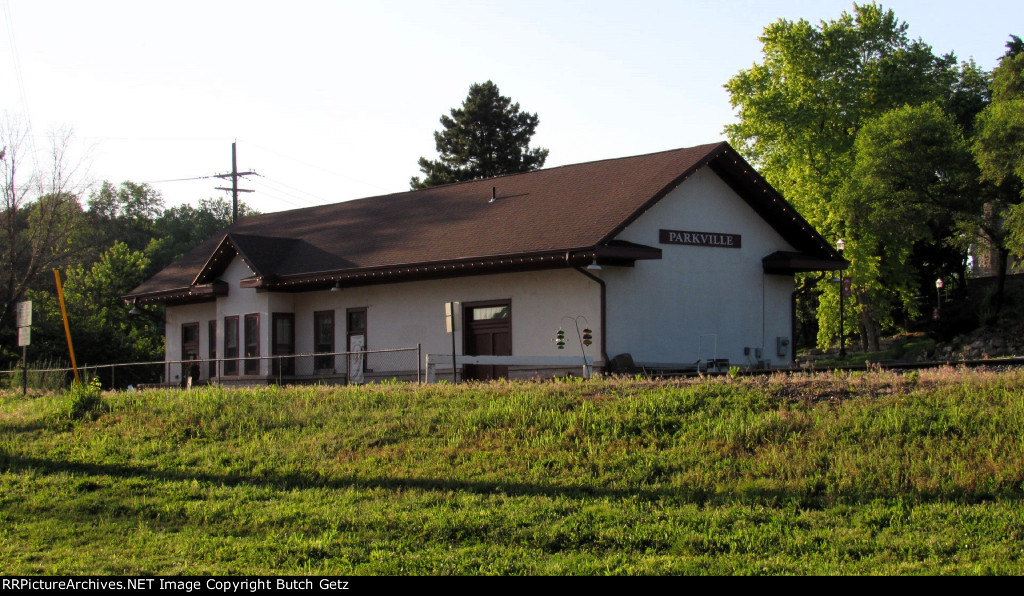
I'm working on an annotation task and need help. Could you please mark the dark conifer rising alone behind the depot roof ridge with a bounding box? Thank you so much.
[410,81,548,188]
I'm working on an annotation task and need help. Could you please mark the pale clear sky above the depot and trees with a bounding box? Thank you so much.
[0,0,1024,212]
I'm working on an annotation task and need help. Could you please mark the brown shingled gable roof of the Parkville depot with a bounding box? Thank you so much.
[126,142,839,301]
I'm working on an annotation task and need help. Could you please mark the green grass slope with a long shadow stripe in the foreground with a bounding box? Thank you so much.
[0,369,1024,574]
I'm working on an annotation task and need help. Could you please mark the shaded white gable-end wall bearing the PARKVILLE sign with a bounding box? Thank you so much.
[602,168,794,366]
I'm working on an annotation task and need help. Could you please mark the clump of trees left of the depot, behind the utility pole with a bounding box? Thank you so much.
[0,125,255,369]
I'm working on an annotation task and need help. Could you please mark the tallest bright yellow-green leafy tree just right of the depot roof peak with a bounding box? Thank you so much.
[726,4,977,348]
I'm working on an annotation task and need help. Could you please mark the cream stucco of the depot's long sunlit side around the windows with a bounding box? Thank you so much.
[167,258,601,381]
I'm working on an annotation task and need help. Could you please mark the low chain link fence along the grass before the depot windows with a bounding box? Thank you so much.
[0,346,423,391]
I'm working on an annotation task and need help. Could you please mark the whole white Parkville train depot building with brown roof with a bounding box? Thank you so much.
[125,142,846,383]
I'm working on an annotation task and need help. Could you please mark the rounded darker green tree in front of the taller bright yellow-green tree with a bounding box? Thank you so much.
[819,102,981,343]
